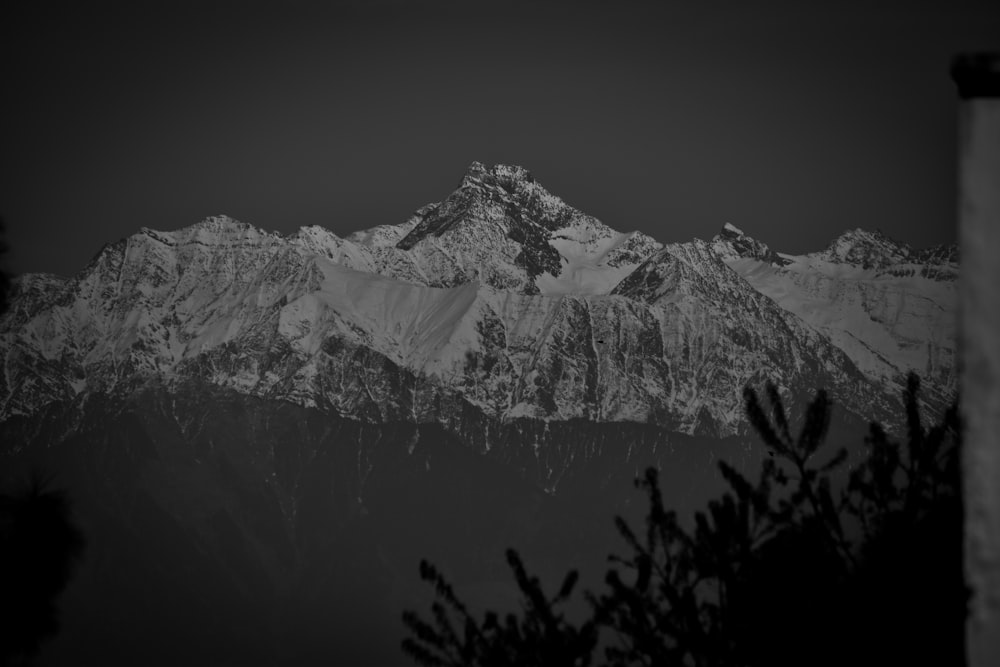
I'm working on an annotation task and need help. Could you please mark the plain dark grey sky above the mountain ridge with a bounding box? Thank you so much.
[0,0,1000,274]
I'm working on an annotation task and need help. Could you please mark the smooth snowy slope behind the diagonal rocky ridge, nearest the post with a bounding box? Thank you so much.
[712,226,958,407]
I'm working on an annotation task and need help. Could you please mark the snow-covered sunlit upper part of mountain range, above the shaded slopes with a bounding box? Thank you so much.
[0,163,957,435]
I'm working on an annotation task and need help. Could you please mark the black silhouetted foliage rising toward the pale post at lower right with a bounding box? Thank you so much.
[403,374,969,667]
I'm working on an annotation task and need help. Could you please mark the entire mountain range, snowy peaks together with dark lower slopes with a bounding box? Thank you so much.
[0,163,958,664]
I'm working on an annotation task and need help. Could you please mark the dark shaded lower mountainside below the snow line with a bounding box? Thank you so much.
[0,385,828,664]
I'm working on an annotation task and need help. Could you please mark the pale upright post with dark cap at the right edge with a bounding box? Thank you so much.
[952,53,1000,667]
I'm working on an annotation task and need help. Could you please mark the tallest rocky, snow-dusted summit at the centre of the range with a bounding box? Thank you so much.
[396,162,660,294]
